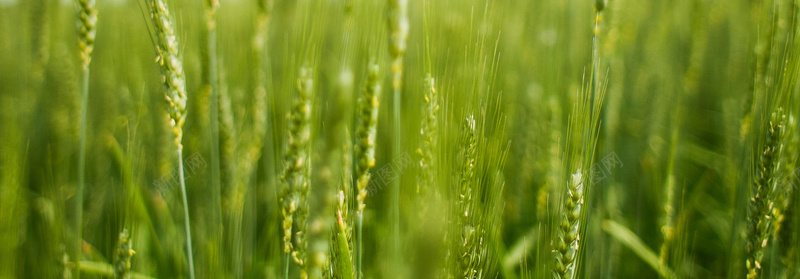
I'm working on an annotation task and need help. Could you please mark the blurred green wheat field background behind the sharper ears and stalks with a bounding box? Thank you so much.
[0,0,800,278]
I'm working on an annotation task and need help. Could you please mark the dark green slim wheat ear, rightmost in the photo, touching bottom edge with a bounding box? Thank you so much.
[745,109,785,278]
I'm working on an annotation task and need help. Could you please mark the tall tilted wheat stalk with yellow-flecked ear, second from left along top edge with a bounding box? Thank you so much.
[147,0,195,279]
